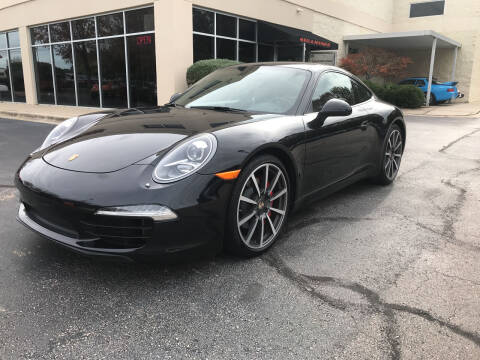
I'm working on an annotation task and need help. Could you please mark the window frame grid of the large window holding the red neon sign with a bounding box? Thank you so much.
[28,4,156,109]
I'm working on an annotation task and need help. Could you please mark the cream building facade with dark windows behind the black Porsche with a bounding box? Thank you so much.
[0,0,480,108]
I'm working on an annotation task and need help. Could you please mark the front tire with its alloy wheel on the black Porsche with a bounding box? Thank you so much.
[225,155,290,257]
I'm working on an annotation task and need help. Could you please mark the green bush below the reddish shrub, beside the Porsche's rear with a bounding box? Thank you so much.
[365,80,425,108]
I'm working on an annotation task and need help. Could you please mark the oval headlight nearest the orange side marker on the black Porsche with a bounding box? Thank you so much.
[153,134,217,183]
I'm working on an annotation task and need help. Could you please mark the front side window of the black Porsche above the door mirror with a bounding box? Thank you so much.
[312,72,355,112]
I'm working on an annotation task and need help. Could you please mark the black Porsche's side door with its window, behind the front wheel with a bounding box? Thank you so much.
[303,71,367,194]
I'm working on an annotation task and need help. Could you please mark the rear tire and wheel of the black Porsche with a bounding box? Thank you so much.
[374,125,404,185]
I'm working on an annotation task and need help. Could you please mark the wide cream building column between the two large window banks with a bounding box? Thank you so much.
[154,0,193,105]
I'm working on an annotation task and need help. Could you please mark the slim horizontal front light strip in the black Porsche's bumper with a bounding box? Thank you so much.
[95,205,178,221]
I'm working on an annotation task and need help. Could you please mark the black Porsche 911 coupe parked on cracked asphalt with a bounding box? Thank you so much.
[15,63,406,259]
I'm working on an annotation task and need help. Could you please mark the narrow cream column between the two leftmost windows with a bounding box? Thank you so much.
[18,26,38,104]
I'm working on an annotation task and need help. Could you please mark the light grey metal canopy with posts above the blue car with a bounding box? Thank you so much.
[343,30,462,106]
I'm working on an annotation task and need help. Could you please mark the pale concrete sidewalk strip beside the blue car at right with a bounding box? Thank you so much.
[402,102,480,118]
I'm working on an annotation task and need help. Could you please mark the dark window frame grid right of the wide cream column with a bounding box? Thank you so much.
[192,5,258,62]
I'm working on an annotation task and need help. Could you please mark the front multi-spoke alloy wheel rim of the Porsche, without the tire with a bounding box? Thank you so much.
[237,163,288,250]
